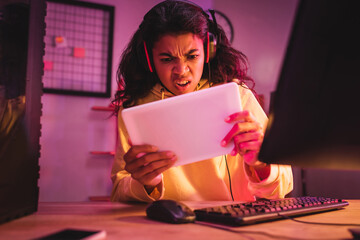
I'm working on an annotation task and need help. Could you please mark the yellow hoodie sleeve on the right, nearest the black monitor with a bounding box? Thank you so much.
[239,86,293,199]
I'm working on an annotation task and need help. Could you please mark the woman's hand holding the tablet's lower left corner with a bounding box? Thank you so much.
[124,144,177,192]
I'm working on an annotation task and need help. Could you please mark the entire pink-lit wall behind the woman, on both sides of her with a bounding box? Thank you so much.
[39,0,297,201]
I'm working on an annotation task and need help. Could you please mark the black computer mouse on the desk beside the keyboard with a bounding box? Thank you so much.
[146,199,195,223]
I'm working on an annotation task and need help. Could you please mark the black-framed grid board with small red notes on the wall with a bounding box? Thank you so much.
[43,0,114,97]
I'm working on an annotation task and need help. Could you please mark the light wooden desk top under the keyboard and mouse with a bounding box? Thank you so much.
[0,200,360,240]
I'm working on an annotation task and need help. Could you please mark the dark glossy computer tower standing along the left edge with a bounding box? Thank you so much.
[0,0,46,223]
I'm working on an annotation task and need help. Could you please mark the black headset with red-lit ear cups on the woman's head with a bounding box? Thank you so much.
[139,1,217,72]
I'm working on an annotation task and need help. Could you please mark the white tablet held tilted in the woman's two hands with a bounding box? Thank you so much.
[122,83,241,166]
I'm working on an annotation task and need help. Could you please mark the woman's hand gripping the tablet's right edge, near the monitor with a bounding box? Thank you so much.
[221,111,264,166]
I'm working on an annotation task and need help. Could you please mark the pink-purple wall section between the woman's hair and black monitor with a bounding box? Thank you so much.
[214,0,298,111]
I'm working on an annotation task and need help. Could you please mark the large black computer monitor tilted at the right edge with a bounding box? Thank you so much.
[259,0,360,170]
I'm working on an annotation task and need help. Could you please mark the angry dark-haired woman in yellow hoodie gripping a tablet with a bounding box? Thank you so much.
[111,0,293,202]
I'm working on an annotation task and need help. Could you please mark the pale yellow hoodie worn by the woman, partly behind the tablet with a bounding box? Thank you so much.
[111,80,293,202]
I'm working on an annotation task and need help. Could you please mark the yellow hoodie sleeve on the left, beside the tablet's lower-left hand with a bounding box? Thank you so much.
[111,110,164,202]
